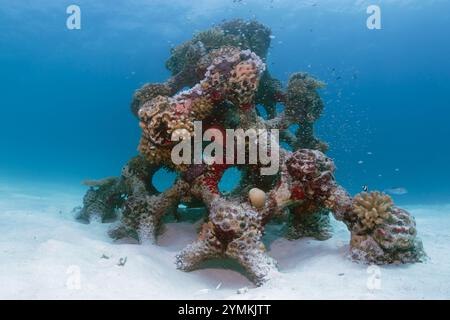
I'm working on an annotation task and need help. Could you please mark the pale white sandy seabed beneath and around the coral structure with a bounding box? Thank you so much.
[0,181,450,299]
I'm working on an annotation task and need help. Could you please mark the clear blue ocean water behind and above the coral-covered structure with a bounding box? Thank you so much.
[0,0,450,203]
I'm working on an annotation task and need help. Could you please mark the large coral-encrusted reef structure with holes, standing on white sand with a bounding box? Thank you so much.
[79,20,425,285]
